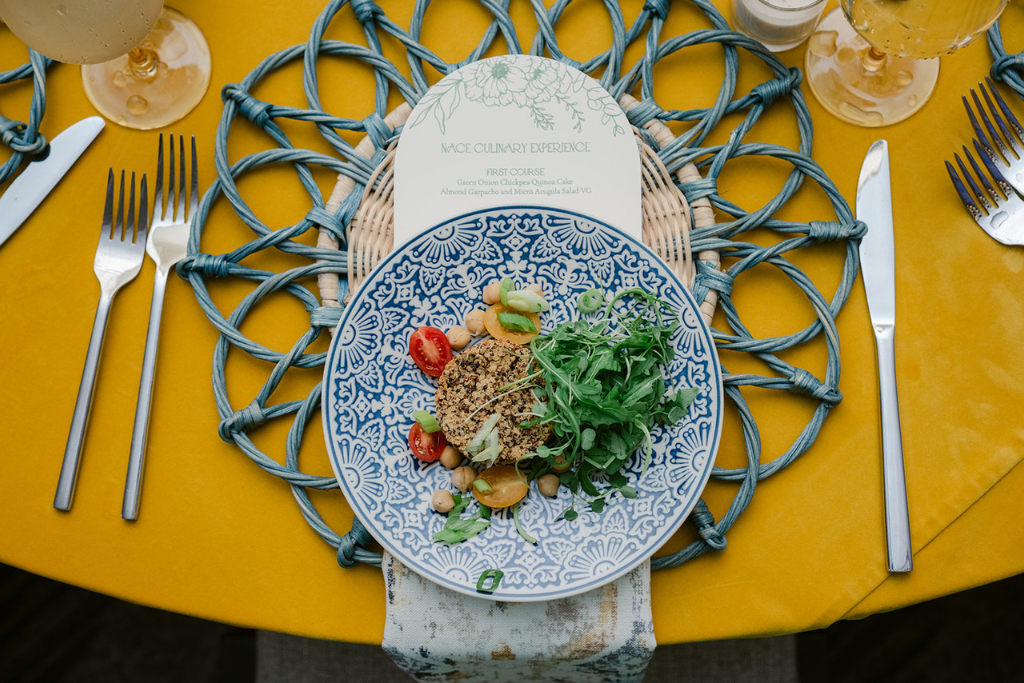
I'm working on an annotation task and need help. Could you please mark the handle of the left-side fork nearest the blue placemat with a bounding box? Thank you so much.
[121,268,167,520]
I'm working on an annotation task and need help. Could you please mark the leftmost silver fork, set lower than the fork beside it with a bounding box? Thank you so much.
[53,169,150,510]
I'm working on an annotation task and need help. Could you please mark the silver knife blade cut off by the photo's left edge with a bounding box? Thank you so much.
[0,116,104,245]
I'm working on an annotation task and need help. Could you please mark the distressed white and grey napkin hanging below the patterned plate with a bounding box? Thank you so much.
[381,553,655,683]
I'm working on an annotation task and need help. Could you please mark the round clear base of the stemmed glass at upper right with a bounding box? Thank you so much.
[805,8,939,128]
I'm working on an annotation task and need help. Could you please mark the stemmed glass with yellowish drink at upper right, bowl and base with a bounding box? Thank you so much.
[806,0,1007,127]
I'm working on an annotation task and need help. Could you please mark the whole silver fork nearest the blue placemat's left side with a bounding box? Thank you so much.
[121,133,199,519]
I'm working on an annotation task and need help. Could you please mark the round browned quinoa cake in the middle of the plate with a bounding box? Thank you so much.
[434,339,551,464]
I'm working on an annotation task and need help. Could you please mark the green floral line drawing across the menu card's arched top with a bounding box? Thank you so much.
[409,55,626,135]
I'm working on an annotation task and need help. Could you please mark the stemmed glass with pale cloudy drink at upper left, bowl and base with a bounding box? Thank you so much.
[0,0,210,130]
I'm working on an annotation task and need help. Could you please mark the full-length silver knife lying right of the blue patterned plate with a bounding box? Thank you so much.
[857,140,913,571]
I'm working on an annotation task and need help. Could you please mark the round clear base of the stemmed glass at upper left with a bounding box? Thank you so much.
[82,7,211,130]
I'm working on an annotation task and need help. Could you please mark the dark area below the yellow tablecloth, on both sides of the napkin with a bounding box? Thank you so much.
[0,564,1024,683]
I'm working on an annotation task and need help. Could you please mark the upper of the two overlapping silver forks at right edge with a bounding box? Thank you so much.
[962,76,1024,193]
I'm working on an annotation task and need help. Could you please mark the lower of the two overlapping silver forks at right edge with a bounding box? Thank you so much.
[946,140,1024,245]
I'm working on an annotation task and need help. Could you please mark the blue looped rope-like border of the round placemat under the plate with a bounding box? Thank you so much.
[178,0,865,568]
